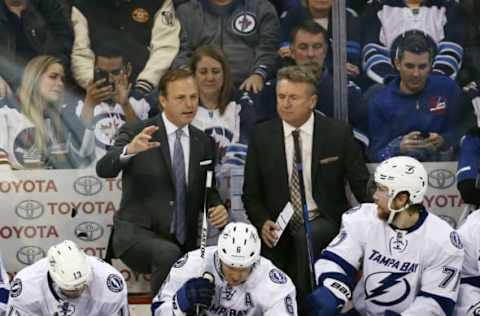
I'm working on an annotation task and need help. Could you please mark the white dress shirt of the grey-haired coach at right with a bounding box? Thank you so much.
[282,113,318,214]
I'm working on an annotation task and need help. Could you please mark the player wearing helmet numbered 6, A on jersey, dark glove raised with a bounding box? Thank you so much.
[152,223,297,316]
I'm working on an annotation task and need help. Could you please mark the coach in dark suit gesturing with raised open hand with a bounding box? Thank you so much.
[97,69,228,294]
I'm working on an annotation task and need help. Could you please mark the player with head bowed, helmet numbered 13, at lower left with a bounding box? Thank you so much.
[7,240,129,316]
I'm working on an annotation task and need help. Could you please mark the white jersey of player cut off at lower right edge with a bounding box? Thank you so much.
[454,210,480,316]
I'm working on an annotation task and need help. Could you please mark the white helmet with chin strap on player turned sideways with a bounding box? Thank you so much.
[375,156,428,223]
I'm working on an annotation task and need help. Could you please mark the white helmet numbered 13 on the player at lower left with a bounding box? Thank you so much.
[47,240,92,291]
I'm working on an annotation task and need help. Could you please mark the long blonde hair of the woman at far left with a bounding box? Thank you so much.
[18,55,65,157]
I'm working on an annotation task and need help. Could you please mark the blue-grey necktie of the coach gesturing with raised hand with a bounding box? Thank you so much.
[173,128,187,245]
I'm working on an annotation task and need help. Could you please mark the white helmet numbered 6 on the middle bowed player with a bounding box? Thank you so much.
[217,222,261,268]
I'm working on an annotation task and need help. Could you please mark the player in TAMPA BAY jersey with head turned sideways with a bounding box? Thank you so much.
[307,156,463,316]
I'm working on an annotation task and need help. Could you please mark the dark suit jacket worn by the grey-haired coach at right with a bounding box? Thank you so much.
[242,114,369,262]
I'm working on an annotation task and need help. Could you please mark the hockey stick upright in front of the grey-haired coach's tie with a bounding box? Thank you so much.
[293,137,317,291]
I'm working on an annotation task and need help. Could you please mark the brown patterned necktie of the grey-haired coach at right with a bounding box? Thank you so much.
[290,129,303,232]
